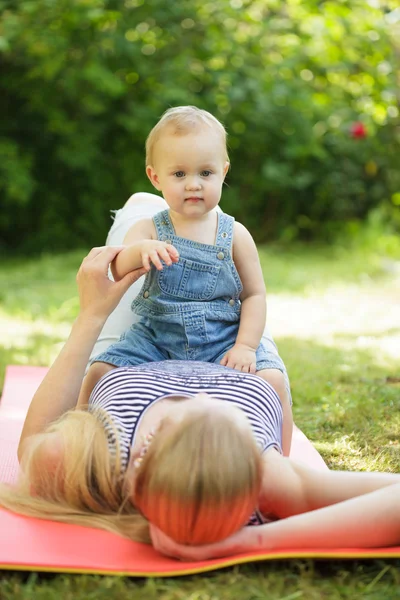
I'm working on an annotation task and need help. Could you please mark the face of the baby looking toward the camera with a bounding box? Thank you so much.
[147,127,229,219]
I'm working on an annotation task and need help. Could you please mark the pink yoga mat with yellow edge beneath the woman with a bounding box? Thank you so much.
[0,367,400,577]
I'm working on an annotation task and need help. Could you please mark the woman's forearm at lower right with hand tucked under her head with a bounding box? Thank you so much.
[151,484,400,560]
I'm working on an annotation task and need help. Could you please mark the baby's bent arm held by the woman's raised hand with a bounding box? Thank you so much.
[111,219,179,281]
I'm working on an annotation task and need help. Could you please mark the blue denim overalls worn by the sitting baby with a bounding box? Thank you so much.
[93,210,284,371]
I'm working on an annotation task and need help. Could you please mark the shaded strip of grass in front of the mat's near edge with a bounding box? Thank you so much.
[0,560,400,600]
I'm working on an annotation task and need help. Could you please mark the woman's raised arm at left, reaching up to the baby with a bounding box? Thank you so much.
[18,247,145,460]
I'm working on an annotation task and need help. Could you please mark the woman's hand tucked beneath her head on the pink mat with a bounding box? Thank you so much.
[150,524,253,561]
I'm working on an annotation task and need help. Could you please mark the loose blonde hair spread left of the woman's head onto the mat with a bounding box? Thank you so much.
[0,410,150,543]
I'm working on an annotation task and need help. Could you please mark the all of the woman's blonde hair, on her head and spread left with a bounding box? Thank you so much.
[0,410,261,544]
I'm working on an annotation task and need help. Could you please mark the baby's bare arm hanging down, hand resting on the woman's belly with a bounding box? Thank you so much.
[221,222,267,373]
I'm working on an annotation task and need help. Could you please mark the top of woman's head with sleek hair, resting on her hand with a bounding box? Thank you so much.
[134,399,261,544]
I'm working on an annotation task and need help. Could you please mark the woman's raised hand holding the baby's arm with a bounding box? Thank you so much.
[76,246,146,320]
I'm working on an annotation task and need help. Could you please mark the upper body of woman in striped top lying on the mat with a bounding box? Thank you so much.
[0,247,400,560]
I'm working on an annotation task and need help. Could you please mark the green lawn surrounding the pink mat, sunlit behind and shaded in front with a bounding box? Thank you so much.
[0,241,400,600]
